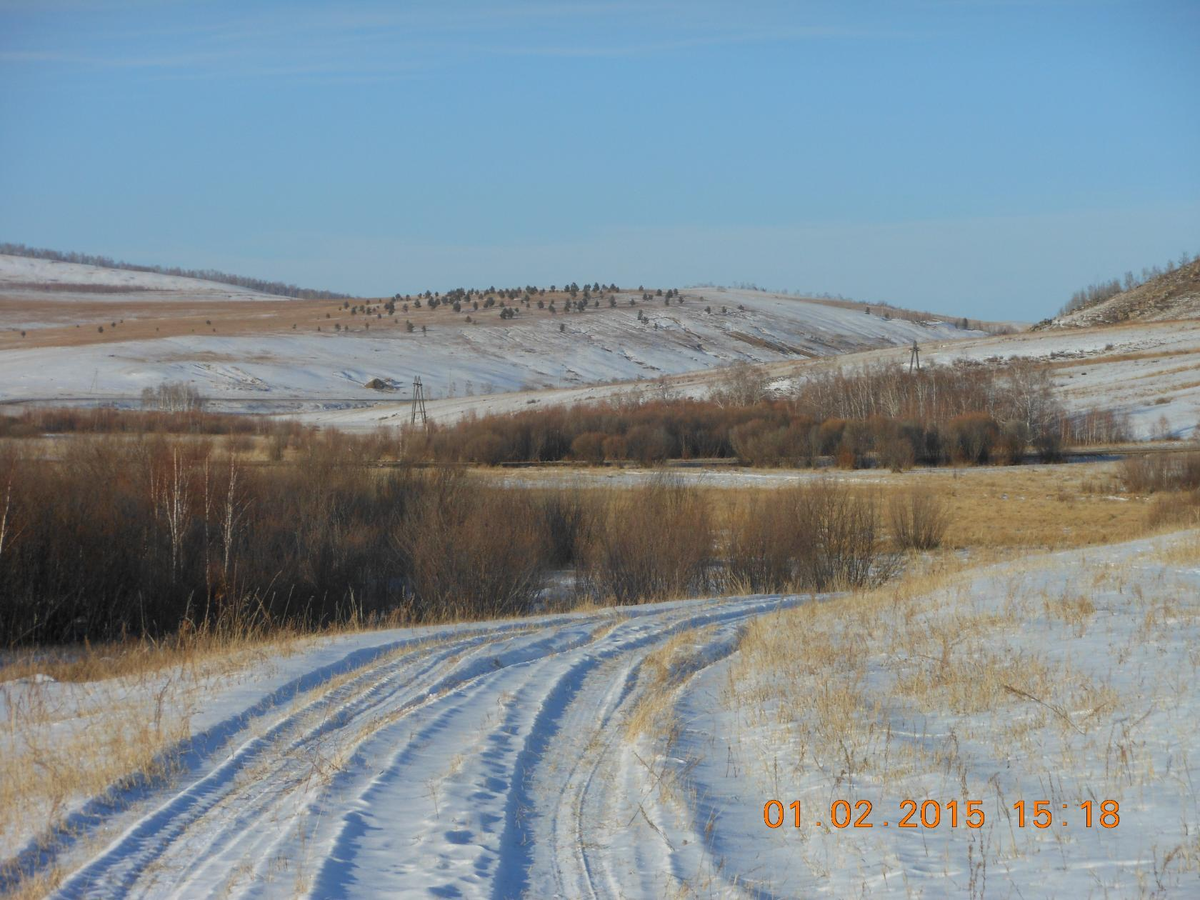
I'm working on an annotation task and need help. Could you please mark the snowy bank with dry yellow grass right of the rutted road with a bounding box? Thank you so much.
[696,532,1200,898]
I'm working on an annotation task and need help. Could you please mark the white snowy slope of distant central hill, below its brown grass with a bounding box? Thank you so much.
[0,288,979,410]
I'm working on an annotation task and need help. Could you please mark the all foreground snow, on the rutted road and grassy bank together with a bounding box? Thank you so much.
[0,533,1200,898]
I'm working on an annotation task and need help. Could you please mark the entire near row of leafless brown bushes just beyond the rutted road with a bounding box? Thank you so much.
[0,433,889,646]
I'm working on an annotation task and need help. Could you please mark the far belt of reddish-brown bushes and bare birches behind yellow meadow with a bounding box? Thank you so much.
[406,361,1128,469]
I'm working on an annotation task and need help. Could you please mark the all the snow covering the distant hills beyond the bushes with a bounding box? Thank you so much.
[0,266,1200,438]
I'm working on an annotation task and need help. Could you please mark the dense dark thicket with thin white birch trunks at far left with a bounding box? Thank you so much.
[0,434,550,643]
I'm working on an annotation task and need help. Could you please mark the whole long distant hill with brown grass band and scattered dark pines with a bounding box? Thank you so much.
[0,257,982,412]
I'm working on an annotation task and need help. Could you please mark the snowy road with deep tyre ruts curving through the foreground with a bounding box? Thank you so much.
[32,598,800,898]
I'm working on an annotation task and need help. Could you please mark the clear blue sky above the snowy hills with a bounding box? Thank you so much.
[0,0,1200,319]
